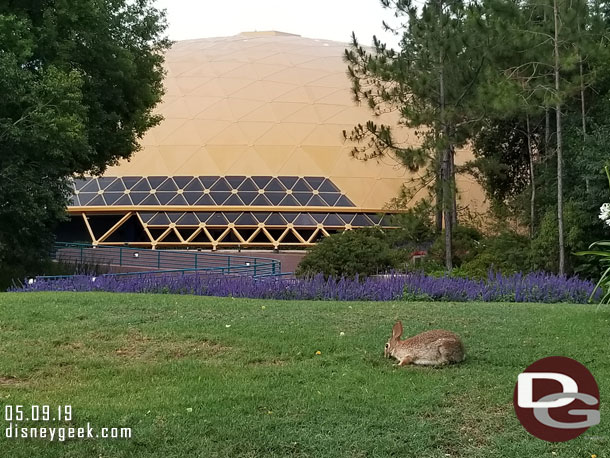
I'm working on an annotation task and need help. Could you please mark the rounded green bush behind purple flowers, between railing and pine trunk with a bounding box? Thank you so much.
[296,228,400,278]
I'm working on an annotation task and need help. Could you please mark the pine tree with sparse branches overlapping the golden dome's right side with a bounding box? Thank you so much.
[344,0,485,270]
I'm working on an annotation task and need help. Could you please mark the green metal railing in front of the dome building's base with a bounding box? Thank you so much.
[43,242,282,278]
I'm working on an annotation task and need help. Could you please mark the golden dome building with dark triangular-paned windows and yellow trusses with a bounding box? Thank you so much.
[63,32,484,249]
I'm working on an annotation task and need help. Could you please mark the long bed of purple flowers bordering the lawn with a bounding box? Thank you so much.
[12,272,595,303]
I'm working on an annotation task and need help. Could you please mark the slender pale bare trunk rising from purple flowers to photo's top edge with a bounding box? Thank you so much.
[553,0,565,275]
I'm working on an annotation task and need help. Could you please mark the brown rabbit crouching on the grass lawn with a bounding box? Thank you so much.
[384,321,465,366]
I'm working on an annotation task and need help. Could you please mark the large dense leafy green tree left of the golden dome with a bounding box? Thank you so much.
[0,0,170,264]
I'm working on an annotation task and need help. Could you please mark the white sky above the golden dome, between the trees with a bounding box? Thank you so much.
[156,0,398,45]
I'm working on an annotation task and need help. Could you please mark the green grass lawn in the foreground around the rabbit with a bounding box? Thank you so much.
[0,293,610,458]
